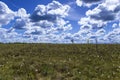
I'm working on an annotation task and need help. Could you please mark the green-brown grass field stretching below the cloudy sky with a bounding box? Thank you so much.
[0,43,120,80]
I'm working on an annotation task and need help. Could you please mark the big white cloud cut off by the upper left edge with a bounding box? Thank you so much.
[0,1,15,26]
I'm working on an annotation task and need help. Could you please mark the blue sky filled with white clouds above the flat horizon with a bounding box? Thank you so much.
[0,0,120,44]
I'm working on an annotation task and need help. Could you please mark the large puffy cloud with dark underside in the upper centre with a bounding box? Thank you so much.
[30,1,70,22]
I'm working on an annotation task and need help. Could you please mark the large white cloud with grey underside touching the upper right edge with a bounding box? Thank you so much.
[86,0,120,21]
